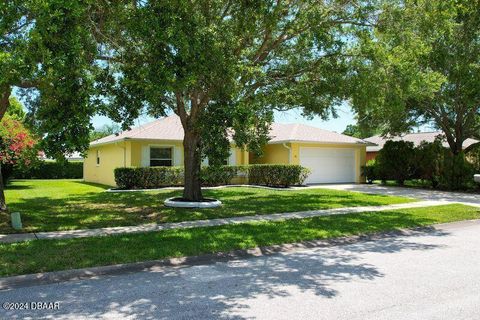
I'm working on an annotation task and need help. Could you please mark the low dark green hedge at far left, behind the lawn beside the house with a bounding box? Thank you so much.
[11,161,83,179]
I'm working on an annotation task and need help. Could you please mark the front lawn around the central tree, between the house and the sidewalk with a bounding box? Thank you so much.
[0,180,414,233]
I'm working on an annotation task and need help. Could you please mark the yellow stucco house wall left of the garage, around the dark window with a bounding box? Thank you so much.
[83,140,249,186]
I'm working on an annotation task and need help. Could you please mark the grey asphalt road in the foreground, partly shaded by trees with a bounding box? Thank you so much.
[0,222,480,320]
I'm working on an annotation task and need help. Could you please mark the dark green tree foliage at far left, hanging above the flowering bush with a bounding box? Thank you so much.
[0,0,105,211]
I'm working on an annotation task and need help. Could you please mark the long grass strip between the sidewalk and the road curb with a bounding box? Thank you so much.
[0,205,480,276]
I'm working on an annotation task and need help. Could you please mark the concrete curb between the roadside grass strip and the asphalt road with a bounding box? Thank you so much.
[0,220,480,291]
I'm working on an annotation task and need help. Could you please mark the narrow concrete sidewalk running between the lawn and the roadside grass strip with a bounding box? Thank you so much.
[0,201,453,243]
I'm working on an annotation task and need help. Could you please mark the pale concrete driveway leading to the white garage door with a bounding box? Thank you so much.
[312,184,480,207]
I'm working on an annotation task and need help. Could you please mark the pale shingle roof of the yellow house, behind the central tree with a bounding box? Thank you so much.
[90,115,369,146]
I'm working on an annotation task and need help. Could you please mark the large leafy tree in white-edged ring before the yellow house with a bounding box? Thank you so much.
[101,0,376,201]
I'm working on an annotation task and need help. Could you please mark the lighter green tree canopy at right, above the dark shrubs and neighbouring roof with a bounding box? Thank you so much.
[352,0,480,154]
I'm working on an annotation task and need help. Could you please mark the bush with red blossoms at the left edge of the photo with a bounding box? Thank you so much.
[0,115,36,181]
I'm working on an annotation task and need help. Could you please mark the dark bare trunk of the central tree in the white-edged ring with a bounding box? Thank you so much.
[183,128,203,201]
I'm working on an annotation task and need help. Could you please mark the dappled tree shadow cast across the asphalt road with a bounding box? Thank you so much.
[3,228,448,319]
